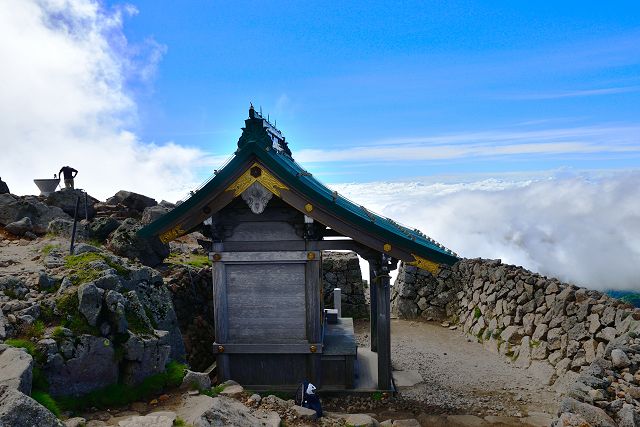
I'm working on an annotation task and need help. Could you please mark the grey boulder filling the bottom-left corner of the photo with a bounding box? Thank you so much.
[0,385,64,427]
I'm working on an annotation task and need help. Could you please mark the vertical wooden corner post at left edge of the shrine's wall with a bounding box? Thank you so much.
[212,243,231,382]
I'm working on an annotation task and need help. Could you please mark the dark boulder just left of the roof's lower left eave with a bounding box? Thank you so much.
[107,218,169,267]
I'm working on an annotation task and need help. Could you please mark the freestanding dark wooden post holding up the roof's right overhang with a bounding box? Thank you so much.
[376,269,391,390]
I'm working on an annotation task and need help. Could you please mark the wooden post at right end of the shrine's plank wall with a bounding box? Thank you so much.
[305,251,322,387]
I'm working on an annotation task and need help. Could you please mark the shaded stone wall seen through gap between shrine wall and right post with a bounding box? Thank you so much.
[322,251,369,318]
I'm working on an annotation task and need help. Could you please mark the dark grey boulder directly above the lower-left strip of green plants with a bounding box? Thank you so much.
[43,335,118,396]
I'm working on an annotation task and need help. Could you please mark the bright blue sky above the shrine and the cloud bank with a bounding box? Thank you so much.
[109,0,640,182]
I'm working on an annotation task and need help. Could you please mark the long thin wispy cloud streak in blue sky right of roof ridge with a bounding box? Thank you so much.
[296,126,640,163]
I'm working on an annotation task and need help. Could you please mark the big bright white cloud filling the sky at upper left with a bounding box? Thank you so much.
[0,0,215,200]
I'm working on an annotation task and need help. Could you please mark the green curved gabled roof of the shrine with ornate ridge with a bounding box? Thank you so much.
[139,107,458,265]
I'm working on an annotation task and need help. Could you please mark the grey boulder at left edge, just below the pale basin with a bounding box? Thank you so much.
[0,194,70,234]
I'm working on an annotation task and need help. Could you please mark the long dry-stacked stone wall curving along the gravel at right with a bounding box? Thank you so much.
[391,259,640,425]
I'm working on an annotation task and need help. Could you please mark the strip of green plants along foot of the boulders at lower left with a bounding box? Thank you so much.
[57,361,187,411]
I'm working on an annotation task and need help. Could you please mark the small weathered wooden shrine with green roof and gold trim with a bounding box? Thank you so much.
[140,107,457,390]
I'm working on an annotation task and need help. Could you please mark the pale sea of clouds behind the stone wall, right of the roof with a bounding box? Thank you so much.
[333,172,640,290]
